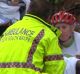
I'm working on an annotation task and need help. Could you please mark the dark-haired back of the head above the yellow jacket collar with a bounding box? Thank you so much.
[28,0,54,19]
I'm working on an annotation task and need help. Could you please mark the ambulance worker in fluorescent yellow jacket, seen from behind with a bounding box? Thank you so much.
[0,0,65,74]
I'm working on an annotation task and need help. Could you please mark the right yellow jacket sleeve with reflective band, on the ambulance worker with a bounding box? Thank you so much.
[44,34,65,74]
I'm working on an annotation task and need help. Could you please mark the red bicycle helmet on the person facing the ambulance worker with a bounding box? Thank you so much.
[51,11,76,25]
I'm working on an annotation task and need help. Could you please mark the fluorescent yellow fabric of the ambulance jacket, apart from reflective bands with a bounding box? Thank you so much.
[0,15,65,74]
